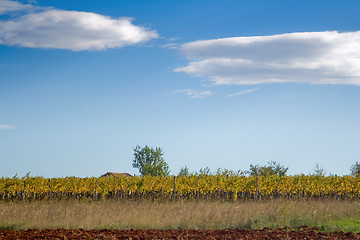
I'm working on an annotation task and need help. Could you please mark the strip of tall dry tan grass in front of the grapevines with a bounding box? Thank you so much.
[0,200,360,229]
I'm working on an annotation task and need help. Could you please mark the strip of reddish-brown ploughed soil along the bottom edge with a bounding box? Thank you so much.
[0,227,360,239]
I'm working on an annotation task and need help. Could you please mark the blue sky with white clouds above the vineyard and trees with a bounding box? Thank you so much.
[0,0,360,177]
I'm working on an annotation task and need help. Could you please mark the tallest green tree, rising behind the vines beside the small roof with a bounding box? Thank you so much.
[132,145,170,176]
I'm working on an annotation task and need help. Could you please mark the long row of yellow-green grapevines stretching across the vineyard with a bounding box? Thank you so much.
[0,175,360,201]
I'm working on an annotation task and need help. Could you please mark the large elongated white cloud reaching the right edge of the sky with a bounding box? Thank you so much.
[174,31,360,85]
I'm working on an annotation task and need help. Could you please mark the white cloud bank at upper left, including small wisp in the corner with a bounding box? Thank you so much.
[0,0,158,51]
